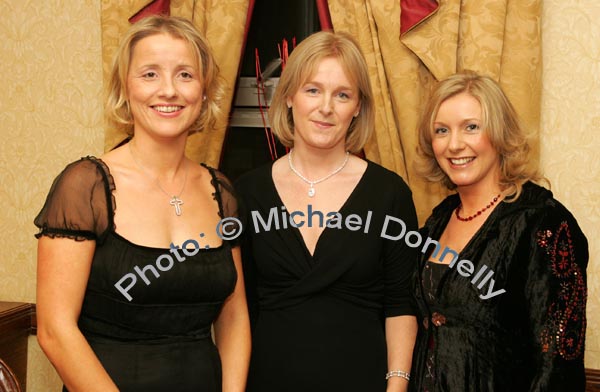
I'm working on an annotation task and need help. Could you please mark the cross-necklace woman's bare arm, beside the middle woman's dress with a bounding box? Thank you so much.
[214,246,250,392]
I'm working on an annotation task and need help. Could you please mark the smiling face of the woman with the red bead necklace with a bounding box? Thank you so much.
[431,93,500,191]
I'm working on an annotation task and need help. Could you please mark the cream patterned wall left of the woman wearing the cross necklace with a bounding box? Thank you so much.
[0,0,104,392]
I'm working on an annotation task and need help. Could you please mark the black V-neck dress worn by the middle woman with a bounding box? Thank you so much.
[236,162,417,392]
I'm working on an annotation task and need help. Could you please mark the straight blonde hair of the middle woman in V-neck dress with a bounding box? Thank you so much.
[269,31,375,153]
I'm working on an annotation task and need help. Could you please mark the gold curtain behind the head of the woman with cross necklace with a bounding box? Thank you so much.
[102,0,249,166]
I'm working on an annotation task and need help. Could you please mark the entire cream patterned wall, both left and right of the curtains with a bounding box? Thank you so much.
[0,0,600,392]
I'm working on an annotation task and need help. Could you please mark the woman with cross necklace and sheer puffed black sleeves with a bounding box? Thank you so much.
[35,16,250,392]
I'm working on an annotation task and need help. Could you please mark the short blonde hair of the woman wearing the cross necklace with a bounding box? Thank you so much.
[105,15,224,135]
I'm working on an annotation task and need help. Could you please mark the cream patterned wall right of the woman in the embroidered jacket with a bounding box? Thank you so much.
[541,0,600,368]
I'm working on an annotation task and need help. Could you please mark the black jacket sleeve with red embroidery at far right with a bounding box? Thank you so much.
[526,201,589,391]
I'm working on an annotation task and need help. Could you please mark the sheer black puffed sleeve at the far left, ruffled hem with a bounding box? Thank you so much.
[34,157,115,243]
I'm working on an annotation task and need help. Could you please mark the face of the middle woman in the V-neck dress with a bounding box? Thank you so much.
[287,57,360,150]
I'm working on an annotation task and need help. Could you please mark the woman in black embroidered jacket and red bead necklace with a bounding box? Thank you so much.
[411,71,588,391]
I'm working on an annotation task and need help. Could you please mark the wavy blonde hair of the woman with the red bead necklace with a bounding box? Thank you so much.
[417,70,544,201]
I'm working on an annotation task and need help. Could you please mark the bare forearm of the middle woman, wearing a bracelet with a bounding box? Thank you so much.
[385,316,417,392]
